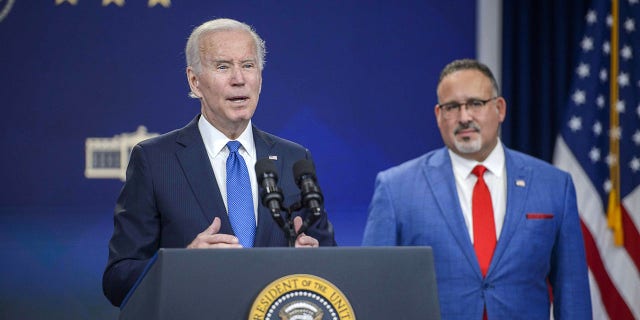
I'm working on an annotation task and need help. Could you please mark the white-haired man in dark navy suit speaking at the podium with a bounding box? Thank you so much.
[102,19,336,306]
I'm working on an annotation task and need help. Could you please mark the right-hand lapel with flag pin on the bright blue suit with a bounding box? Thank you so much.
[487,148,533,276]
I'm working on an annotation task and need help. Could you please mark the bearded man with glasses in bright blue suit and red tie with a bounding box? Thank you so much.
[363,59,591,320]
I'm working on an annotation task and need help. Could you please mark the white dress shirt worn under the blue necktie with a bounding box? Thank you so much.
[198,115,258,224]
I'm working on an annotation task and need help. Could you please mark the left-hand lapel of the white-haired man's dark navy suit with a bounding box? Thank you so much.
[176,117,233,234]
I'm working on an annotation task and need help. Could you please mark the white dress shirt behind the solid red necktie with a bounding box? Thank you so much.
[448,139,507,243]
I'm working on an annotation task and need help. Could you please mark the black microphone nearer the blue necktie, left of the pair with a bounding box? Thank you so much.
[255,158,284,218]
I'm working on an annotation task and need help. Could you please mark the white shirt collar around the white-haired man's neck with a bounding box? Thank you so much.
[198,115,256,159]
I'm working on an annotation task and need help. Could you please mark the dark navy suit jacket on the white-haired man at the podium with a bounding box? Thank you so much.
[102,116,336,306]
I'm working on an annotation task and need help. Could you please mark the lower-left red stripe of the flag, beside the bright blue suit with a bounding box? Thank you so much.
[580,221,633,319]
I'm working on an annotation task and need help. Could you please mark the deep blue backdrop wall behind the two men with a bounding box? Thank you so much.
[0,0,475,319]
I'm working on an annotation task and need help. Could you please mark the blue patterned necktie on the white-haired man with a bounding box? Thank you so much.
[227,141,256,248]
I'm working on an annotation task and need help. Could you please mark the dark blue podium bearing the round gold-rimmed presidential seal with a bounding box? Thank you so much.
[120,247,440,320]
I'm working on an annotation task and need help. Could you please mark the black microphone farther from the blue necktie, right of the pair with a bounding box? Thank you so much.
[293,159,324,216]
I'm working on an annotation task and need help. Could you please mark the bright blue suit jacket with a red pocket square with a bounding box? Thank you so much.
[363,148,591,320]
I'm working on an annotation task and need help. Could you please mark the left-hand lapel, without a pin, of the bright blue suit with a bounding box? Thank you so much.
[423,148,481,276]
